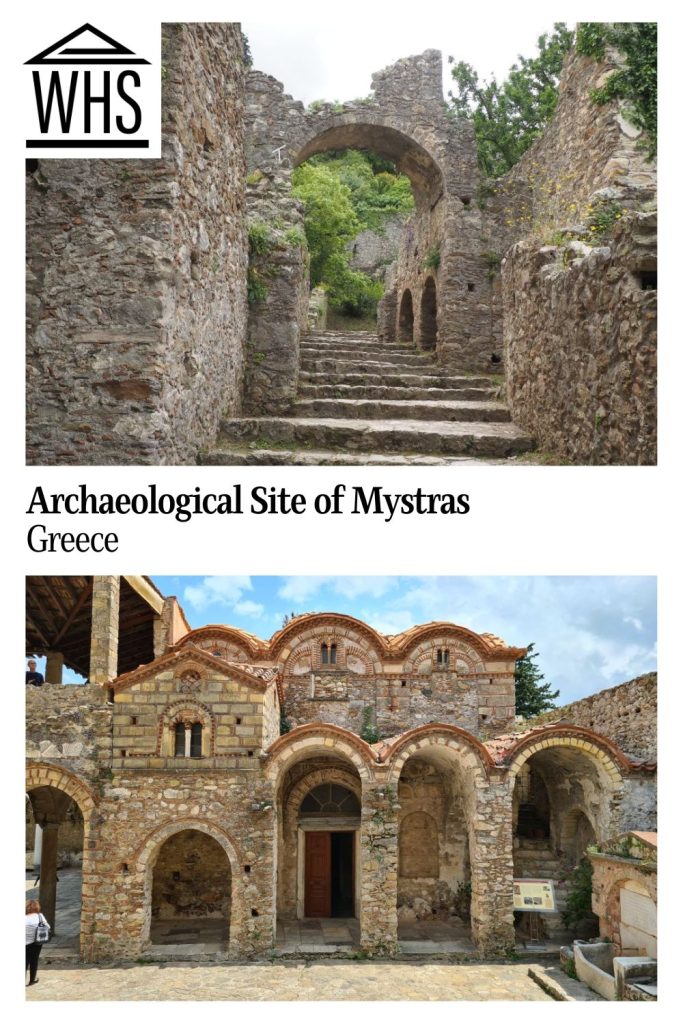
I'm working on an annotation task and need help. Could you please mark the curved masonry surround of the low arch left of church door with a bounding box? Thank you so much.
[131,818,246,954]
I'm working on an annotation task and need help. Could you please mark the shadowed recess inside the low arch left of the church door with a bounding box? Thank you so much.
[150,828,232,948]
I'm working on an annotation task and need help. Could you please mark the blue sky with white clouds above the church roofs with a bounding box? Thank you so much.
[153,575,656,702]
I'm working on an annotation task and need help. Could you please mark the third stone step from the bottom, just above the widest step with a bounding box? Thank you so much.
[293,398,510,423]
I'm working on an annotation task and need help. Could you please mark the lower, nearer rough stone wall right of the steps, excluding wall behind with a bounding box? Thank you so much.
[503,213,656,465]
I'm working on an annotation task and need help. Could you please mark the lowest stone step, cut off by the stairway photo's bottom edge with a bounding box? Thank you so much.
[199,443,520,466]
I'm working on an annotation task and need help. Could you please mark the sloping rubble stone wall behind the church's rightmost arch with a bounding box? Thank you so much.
[530,672,657,765]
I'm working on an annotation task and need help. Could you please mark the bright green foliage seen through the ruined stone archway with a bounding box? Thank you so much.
[292,151,413,316]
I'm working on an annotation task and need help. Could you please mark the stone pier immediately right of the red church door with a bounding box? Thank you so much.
[360,780,398,953]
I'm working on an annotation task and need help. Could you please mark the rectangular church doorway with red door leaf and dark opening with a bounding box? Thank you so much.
[304,830,354,918]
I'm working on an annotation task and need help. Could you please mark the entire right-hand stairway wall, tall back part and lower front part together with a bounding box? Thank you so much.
[491,46,656,465]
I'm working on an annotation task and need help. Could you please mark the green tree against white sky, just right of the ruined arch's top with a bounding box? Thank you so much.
[449,22,573,177]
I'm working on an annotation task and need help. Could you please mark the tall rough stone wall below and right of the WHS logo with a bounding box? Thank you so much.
[27,24,247,465]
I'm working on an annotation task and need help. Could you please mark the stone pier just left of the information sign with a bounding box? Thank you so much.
[470,779,515,955]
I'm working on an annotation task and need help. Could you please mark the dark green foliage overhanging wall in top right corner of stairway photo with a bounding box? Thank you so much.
[577,22,657,160]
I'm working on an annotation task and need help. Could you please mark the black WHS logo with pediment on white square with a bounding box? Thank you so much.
[25,23,161,158]
